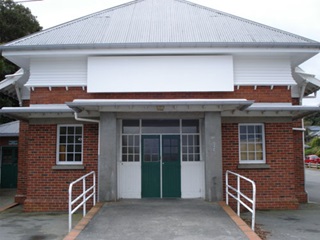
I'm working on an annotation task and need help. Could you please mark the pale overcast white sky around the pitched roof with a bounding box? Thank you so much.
[18,0,320,105]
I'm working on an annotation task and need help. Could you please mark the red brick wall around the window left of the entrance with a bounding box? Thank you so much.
[21,124,98,211]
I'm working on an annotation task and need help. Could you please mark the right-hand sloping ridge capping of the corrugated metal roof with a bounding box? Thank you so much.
[180,0,318,43]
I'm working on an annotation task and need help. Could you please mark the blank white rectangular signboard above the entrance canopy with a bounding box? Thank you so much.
[87,56,234,93]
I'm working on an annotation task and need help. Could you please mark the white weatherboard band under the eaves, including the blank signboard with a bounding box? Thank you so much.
[26,55,297,93]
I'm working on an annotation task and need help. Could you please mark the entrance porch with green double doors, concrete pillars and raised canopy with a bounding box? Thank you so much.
[67,99,252,201]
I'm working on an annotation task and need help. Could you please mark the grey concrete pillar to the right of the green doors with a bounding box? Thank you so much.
[204,112,223,201]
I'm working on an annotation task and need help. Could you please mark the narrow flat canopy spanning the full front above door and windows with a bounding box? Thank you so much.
[0,99,320,120]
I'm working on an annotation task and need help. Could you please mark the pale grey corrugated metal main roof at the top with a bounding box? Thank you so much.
[2,0,320,49]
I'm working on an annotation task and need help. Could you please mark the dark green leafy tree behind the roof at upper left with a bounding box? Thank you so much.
[0,0,42,80]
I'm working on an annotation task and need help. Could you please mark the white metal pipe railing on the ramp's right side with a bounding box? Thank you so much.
[226,170,256,230]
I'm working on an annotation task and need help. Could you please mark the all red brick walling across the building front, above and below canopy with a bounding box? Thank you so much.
[18,86,306,211]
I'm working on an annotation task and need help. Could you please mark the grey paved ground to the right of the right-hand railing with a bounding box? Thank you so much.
[241,169,320,240]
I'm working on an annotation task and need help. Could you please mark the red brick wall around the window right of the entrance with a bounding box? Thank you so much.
[222,123,305,209]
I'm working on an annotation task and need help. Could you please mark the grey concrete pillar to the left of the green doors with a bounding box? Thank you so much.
[98,112,117,202]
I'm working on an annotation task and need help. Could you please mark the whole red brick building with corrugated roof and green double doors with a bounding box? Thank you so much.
[1,0,320,211]
